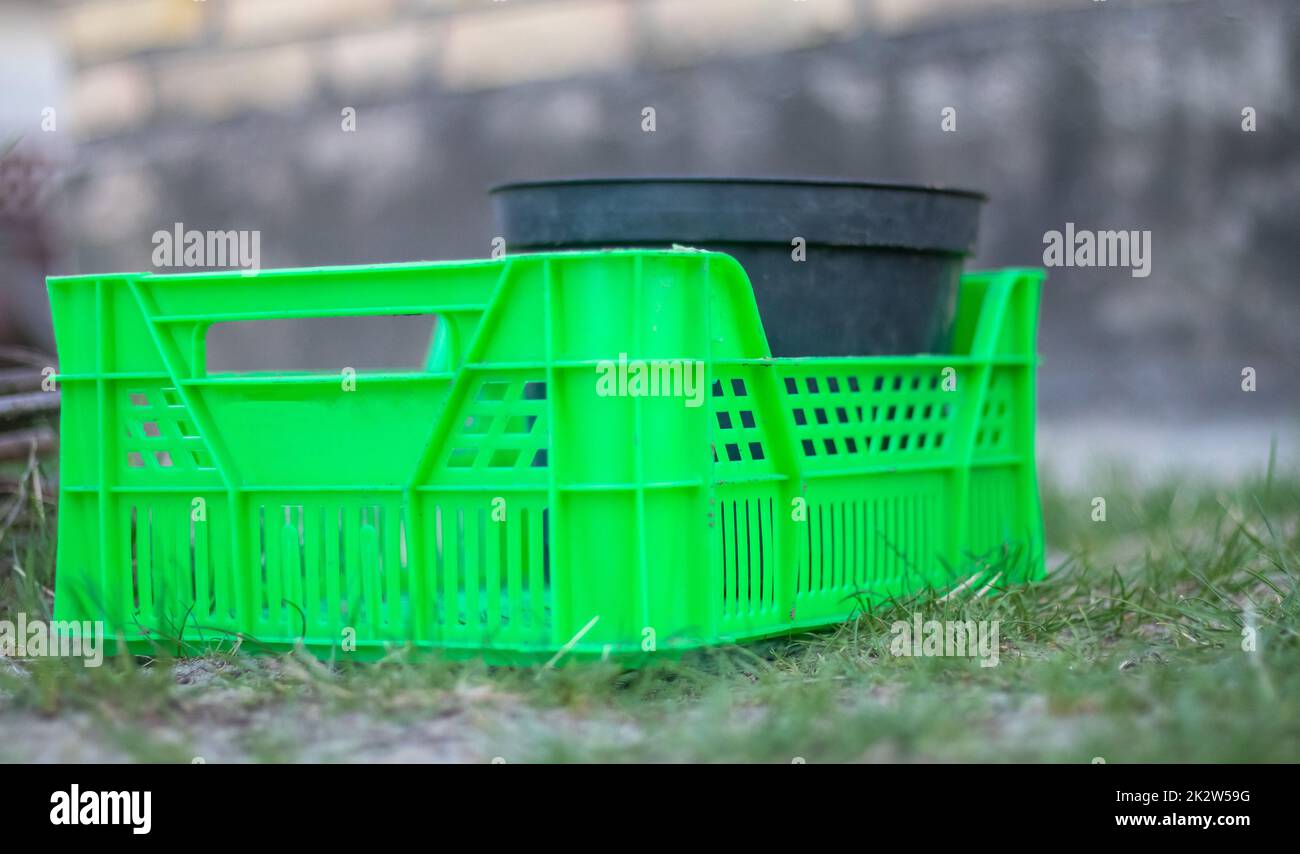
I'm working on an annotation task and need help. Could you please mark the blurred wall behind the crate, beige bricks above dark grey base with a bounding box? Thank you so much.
[5,0,1300,422]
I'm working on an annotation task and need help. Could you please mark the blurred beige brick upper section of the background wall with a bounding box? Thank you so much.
[43,0,1184,138]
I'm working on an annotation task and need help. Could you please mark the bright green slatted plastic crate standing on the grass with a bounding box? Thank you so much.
[49,251,1043,662]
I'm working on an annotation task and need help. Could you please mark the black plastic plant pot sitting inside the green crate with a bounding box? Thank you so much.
[491,178,984,356]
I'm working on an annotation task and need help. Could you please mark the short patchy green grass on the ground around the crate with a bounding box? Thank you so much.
[0,462,1300,763]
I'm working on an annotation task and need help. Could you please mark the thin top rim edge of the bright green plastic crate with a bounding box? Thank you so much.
[46,247,1044,285]
